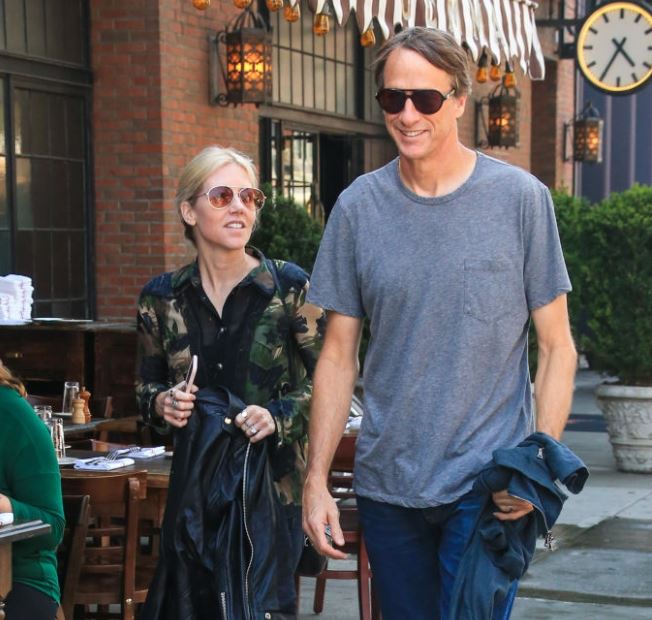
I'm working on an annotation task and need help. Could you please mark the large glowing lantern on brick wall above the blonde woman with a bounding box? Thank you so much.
[208,8,272,105]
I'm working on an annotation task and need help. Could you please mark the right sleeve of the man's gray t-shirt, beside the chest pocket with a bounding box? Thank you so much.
[523,185,571,310]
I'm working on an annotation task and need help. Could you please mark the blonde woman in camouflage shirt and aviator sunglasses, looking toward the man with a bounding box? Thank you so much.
[137,146,324,614]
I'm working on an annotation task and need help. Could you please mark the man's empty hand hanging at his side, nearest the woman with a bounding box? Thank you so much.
[303,477,346,560]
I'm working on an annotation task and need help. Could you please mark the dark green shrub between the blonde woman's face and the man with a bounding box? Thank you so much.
[251,185,322,272]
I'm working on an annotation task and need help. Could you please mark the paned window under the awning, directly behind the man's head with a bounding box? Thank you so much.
[260,5,395,221]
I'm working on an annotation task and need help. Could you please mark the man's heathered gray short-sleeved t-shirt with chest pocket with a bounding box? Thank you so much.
[308,153,570,508]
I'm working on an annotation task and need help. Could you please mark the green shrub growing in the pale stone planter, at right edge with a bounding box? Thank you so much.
[581,185,652,385]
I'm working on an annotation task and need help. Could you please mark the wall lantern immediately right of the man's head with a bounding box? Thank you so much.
[475,80,521,148]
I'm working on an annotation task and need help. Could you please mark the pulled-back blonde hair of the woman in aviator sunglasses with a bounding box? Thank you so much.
[174,145,258,244]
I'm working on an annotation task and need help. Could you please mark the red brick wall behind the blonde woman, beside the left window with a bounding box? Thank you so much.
[91,0,258,319]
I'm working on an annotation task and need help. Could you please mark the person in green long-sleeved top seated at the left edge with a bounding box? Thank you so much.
[0,361,65,620]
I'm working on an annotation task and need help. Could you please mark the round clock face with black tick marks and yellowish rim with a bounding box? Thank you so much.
[576,2,652,94]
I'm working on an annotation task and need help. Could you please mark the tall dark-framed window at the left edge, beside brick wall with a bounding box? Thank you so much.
[0,0,92,318]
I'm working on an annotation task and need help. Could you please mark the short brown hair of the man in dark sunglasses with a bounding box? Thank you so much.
[372,26,471,97]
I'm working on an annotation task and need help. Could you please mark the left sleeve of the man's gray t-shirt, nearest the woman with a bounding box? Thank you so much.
[307,199,365,318]
